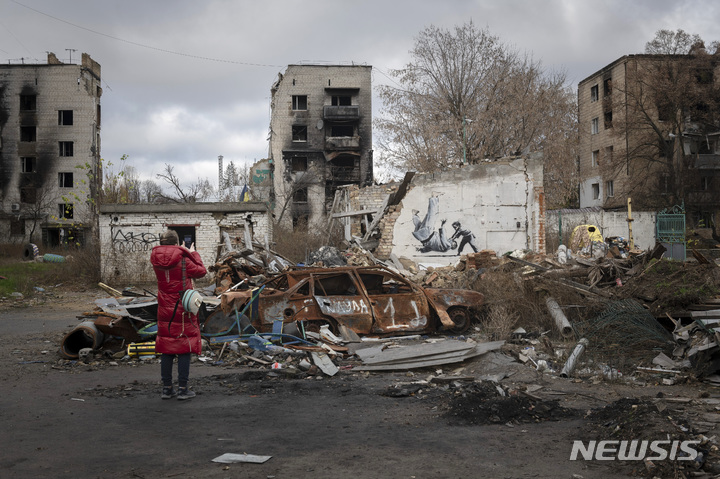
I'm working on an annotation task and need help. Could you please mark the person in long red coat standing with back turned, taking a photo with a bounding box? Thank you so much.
[150,230,207,399]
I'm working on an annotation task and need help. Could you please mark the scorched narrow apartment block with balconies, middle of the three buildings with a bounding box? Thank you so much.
[270,65,373,228]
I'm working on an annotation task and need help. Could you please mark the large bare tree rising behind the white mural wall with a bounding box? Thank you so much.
[376,22,576,175]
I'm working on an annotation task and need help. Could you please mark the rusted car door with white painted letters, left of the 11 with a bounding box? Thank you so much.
[313,271,373,334]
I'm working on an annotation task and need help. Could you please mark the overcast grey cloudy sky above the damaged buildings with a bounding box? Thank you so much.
[0,0,720,191]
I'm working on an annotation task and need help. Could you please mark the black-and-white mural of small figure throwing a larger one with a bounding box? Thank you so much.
[412,194,478,256]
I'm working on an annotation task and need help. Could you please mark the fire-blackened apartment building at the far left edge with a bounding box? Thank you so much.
[0,53,102,246]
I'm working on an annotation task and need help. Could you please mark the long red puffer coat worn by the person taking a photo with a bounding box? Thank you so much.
[150,245,207,354]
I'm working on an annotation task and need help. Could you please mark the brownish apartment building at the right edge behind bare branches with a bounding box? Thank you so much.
[578,49,720,225]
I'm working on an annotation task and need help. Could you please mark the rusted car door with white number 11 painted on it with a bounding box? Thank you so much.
[358,269,433,333]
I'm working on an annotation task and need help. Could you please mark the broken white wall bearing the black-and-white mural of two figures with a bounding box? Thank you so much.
[393,159,544,265]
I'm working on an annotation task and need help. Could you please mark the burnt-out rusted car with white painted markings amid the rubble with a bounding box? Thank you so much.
[222,266,483,335]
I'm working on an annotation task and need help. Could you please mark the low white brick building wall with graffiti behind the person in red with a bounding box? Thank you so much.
[99,205,272,289]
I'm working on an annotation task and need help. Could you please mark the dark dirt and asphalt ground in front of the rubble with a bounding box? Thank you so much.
[0,290,720,479]
